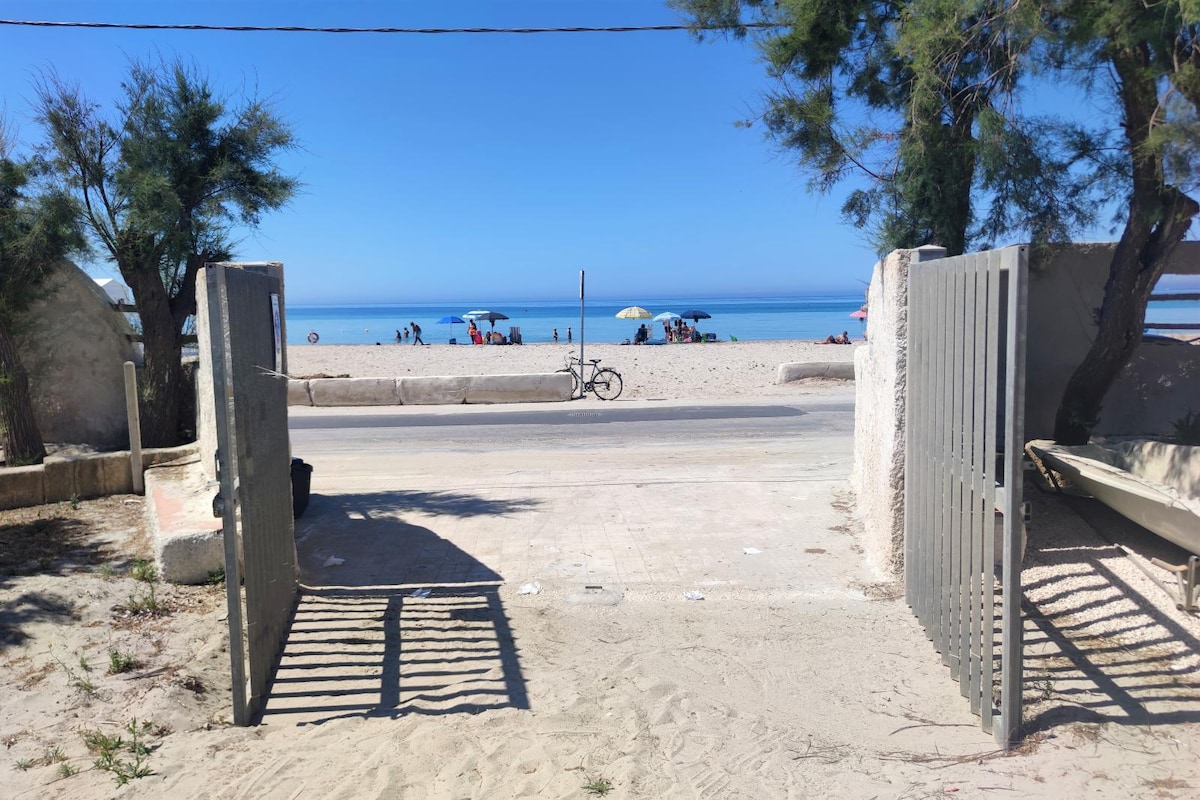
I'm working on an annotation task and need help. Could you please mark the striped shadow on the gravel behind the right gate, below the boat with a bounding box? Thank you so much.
[1022,493,1200,733]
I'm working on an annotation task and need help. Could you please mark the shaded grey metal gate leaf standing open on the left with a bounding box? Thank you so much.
[204,264,296,724]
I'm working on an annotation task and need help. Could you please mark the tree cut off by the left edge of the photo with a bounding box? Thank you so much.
[0,149,83,464]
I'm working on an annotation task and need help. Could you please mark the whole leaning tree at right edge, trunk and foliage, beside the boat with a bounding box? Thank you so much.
[1054,0,1200,445]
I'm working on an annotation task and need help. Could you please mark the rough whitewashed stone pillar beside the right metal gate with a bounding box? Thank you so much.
[850,246,946,577]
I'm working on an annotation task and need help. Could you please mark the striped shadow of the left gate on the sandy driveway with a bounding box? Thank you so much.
[262,492,532,724]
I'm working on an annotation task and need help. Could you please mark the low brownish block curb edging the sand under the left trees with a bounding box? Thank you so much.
[0,443,199,510]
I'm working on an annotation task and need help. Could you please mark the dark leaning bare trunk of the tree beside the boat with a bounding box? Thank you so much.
[1054,49,1200,445]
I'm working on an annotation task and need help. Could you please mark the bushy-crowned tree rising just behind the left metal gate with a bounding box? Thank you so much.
[36,61,299,446]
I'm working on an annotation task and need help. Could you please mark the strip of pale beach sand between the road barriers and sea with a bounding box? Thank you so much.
[288,341,857,401]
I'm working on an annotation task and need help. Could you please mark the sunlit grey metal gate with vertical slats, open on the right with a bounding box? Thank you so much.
[905,247,1028,745]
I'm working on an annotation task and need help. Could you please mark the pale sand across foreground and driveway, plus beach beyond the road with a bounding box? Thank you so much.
[0,342,1200,800]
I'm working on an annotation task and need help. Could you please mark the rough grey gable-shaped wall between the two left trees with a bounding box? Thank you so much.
[17,261,140,447]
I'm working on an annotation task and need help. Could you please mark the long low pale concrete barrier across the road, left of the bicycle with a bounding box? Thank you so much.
[288,372,571,408]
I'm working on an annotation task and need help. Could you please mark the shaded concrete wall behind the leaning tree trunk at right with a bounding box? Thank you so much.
[1025,242,1200,440]
